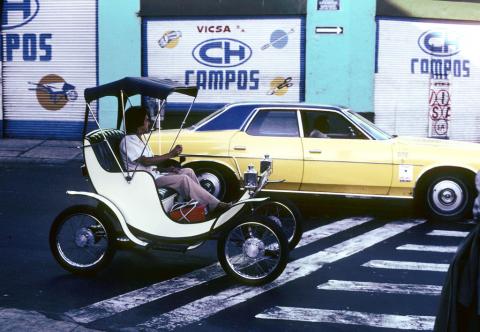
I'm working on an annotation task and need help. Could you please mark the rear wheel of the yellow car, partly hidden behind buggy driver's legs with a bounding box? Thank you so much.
[194,165,240,202]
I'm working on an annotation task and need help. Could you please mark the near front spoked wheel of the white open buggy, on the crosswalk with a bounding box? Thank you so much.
[217,216,288,286]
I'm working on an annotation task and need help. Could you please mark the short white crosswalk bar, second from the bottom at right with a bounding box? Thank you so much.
[317,280,442,296]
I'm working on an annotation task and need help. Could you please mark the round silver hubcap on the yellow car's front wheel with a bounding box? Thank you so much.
[432,180,465,212]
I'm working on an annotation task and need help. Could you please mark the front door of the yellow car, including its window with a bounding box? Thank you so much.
[300,109,392,195]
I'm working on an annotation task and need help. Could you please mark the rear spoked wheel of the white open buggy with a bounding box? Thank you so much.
[49,205,115,275]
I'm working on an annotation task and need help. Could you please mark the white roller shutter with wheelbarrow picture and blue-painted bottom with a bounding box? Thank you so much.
[2,0,97,139]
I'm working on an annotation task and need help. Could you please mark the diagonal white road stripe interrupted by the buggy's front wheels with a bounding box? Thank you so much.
[65,218,372,324]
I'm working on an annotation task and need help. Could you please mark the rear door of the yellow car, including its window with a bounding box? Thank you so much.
[230,108,303,190]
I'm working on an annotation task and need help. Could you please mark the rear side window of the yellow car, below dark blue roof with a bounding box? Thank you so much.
[247,110,300,137]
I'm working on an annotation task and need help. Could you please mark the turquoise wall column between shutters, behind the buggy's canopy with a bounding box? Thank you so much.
[98,0,141,127]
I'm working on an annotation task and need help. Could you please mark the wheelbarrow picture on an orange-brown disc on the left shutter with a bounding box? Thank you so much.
[30,74,78,111]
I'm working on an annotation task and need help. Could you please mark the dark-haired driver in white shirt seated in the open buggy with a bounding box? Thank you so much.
[120,106,231,212]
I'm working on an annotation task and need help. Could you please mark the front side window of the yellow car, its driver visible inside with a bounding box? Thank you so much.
[302,111,367,139]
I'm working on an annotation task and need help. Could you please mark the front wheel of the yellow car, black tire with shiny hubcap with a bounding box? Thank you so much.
[419,174,474,222]
